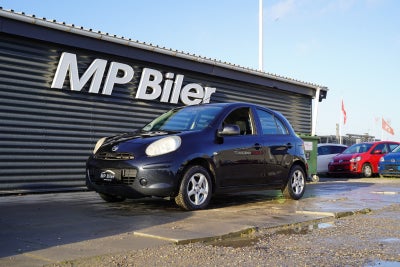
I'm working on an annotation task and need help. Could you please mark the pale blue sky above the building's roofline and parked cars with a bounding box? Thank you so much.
[0,0,400,141]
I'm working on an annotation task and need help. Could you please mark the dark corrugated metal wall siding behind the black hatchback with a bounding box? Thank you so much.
[0,35,311,193]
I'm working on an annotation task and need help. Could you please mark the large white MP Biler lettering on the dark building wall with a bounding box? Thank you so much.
[51,52,216,105]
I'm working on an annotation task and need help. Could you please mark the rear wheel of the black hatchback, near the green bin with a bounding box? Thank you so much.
[282,165,306,200]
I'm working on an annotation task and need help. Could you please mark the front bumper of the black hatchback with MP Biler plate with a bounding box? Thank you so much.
[86,157,179,198]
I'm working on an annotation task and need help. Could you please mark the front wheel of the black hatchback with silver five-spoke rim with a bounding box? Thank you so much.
[175,165,212,210]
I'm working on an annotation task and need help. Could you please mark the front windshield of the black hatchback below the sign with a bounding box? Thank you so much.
[142,106,222,132]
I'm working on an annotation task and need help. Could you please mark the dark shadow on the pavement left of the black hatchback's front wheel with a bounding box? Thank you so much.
[0,192,186,258]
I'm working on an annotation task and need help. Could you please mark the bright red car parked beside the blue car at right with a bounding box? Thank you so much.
[328,141,400,177]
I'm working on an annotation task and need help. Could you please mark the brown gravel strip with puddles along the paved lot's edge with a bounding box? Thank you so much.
[50,204,400,267]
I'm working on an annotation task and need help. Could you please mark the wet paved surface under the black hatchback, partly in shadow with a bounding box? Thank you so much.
[0,178,400,266]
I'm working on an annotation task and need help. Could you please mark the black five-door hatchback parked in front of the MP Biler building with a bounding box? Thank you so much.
[86,103,307,210]
